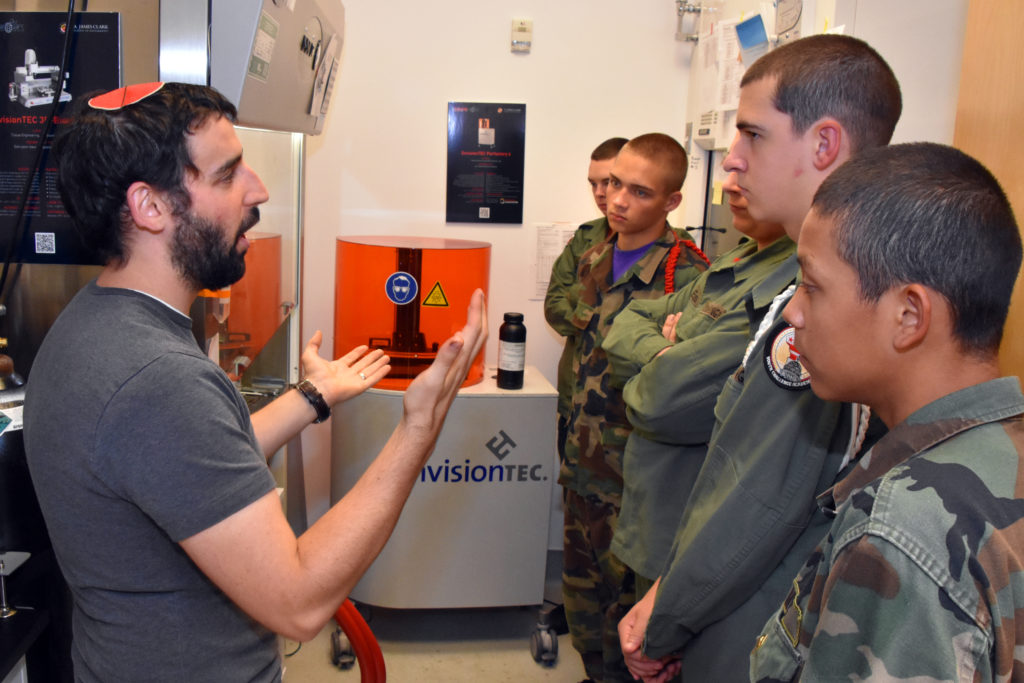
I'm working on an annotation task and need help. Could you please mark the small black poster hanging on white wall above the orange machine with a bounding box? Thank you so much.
[445,102,526,223]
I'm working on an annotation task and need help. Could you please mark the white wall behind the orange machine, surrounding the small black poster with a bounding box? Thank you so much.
[302,0,699,522]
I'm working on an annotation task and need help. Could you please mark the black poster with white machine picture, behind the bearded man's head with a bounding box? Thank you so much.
[0,12,121,264]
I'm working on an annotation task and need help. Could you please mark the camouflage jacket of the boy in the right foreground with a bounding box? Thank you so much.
[751,377,1024,681]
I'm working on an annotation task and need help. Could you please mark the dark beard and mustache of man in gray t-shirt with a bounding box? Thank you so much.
[171,207,259,290]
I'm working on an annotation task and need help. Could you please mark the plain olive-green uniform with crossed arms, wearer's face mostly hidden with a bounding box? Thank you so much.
[604,236,797,580]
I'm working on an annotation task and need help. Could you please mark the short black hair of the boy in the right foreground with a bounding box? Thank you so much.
[811,142,1021,355]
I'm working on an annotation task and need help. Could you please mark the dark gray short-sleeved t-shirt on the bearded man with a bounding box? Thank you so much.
[25,283,281,682]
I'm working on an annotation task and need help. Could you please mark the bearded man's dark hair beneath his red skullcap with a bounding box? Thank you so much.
[52,83,237,264]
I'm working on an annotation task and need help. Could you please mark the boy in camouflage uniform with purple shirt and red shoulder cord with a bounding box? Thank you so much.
[558,133,707,682]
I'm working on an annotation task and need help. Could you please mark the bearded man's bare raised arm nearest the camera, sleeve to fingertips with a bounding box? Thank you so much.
[181,291,486,640]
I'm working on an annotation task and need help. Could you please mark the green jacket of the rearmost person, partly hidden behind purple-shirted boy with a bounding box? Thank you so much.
[544,216,609,418]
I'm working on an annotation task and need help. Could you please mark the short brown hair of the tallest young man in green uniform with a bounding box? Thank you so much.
[740,34,903,153]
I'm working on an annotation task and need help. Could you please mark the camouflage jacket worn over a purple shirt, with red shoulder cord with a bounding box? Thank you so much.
[558,223,707,506]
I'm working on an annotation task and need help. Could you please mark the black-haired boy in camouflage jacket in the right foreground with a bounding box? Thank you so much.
[751,143,1024,681]
